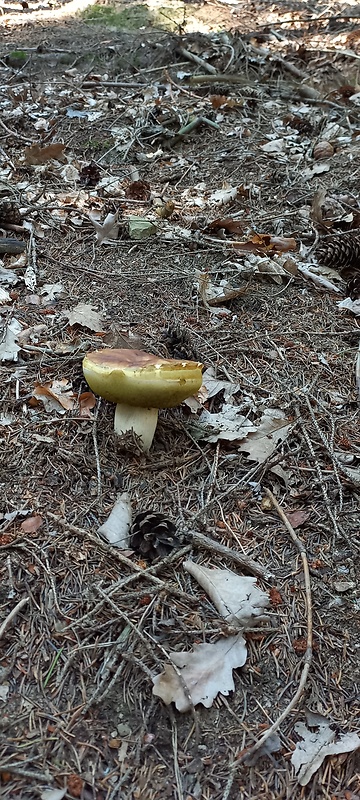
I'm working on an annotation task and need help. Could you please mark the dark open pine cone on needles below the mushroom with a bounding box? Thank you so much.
[130,511,182,561]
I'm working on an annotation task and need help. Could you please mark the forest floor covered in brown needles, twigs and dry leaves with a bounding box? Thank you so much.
[0,0,360,800]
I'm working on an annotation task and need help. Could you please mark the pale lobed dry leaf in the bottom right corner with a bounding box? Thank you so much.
[291,712,360,786]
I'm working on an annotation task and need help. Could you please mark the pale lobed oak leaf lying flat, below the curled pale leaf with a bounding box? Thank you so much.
[153,634,247,712]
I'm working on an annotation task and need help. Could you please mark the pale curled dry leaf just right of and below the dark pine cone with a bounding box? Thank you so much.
[184,561,269,628]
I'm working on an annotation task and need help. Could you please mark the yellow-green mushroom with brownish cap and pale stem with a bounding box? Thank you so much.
[83,350,203,451]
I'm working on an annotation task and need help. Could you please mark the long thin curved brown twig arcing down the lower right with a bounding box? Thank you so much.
[222,489,313,800]
